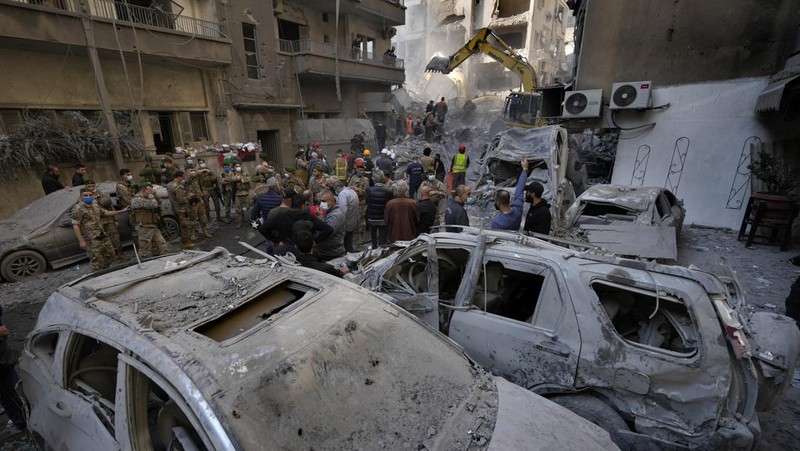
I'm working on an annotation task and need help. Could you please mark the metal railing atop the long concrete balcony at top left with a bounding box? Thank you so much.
[7,0,225,39]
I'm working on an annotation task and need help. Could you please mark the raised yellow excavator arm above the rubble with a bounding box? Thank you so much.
[425,28,536,92]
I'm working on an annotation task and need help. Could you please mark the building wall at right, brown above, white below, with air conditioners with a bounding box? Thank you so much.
[562,0,800,229]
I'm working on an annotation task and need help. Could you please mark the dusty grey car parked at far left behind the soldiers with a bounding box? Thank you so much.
[0,182,180,281]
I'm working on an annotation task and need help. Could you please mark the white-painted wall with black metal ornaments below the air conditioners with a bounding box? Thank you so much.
[604,77,772,229]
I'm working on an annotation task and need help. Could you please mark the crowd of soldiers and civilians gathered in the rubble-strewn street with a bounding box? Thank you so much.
[42,141,550,275]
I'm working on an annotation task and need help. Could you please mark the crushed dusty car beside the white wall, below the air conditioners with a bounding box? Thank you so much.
[565,184,686,260]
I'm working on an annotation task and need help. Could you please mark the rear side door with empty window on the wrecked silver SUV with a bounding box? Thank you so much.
[448,244,581,392]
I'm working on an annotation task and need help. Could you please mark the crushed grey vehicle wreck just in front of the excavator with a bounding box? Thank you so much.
[475,125,575,230]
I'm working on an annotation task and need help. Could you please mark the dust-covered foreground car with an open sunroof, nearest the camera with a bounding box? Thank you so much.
[19,248,614,450]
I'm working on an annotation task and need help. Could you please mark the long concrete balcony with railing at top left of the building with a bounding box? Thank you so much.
[0,0,231,67]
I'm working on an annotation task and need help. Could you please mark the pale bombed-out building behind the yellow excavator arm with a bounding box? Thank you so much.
[394,0,570,104]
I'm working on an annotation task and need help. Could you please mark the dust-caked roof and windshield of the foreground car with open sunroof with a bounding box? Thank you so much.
[59,248,506,449]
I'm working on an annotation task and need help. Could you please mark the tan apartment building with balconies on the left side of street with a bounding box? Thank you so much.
[0,0,405,217]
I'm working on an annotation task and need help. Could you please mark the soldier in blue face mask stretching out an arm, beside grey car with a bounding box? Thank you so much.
[71,189,128,271]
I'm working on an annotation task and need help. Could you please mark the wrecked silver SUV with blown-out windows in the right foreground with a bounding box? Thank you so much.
[351,228,800,449]
